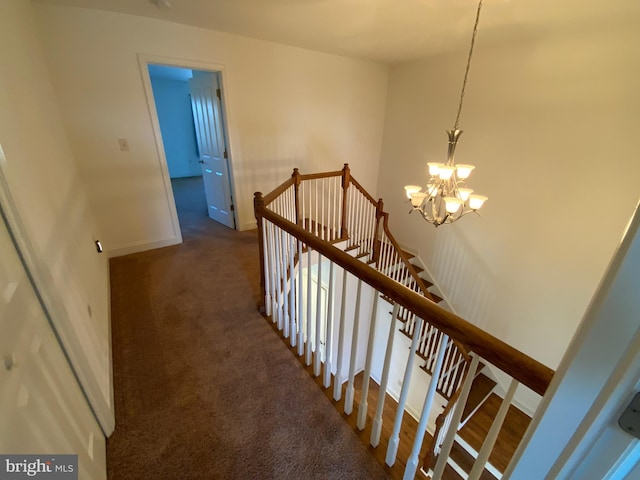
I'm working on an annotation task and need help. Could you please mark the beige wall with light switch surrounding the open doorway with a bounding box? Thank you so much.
[35,5,388,253]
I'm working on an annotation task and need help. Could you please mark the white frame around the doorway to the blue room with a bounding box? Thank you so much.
[138,53,240,236]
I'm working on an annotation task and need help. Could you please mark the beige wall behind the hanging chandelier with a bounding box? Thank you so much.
[378,7,640,404]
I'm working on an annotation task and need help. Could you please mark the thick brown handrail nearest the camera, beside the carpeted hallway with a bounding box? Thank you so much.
[254,192,554,395]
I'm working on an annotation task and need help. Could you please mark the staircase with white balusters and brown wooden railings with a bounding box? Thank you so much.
[254,165,553,480]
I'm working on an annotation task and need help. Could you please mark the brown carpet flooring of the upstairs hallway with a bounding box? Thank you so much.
[107,179,387,480]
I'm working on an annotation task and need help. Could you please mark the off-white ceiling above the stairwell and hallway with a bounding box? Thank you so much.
[34,0,640,63]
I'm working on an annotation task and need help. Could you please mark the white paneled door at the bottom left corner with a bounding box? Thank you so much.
[0,217,106,479]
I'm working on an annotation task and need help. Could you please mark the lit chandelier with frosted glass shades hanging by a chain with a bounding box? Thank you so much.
[404,0,487,227]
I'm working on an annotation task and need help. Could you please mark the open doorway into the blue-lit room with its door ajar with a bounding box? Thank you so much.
[143,62,236,240]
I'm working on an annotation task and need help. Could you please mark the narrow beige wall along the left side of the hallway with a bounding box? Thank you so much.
[0,0,113,431]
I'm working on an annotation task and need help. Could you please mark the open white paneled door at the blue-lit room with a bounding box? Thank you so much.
[189,71,235,228]
